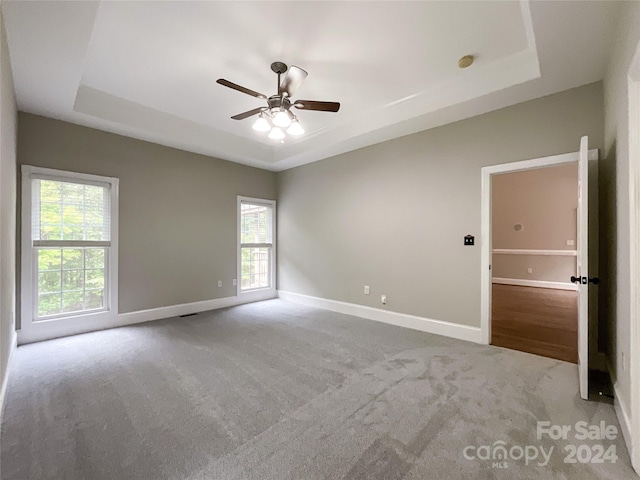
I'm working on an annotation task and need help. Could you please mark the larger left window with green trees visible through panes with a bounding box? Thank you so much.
[23,167,117,322]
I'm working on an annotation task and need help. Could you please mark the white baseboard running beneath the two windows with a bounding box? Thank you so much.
[18,290,278,345]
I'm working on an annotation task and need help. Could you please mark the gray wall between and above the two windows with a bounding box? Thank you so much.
[18,112,276,312]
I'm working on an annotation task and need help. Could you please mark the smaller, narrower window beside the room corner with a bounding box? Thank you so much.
[238,197,275,292]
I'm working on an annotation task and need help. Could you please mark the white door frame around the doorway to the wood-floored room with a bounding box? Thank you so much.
[480,149,598,345]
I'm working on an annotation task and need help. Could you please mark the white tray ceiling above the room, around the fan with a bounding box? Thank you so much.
[2,0,619,171]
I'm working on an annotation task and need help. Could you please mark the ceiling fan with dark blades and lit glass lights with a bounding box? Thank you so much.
[217,62,340,140]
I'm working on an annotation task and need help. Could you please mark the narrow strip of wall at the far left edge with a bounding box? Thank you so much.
[0,10,17,401]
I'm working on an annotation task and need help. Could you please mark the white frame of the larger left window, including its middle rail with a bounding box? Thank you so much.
[20,165,119,330]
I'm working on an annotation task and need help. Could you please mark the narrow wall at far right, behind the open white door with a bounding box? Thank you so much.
[599,2,640,460]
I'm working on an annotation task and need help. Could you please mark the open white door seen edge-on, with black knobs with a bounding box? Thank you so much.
[571,137,589,400]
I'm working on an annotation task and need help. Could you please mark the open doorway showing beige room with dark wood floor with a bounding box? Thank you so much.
[490,162,578,364]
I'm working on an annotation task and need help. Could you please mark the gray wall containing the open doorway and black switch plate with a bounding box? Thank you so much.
[278,82,604,326]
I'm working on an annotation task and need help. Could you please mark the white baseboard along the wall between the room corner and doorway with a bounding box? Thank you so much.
[278,290,481,343]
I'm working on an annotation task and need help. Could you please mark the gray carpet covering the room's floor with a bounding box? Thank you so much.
[1,300,637,480]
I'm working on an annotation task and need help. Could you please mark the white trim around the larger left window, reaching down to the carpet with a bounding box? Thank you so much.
[18,165,119,343]
